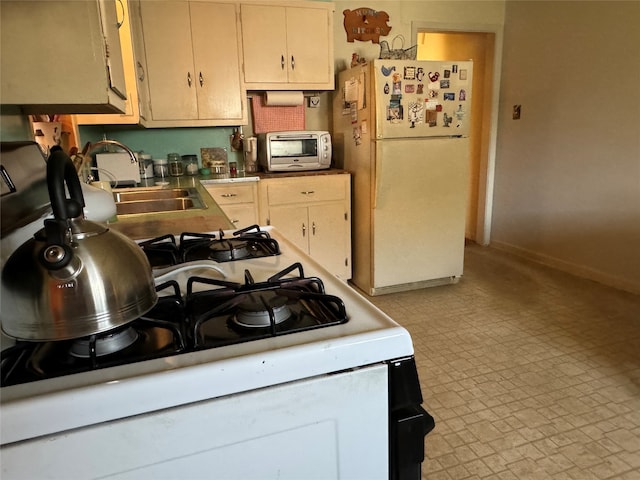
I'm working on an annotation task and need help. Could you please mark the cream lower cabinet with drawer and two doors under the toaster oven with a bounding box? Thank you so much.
[259,174,351,280]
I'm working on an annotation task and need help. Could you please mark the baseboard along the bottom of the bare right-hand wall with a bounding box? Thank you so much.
[489,240,640,295]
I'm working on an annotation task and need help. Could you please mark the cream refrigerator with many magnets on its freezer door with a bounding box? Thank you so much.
[333,60,473,295]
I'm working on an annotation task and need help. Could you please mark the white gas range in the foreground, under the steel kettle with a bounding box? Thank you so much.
[0,142,433,480]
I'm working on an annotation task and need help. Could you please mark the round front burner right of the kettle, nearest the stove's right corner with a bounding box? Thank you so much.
[233,291,292,328]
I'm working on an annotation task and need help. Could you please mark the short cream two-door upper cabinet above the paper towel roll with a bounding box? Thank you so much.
[241,2,334,90]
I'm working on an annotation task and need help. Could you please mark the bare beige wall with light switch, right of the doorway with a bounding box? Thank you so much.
[492,1,640,292]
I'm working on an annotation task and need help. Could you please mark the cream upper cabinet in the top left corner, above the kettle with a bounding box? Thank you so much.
[0,0,127,113]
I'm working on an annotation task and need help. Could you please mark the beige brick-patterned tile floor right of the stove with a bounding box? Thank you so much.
[364,245,640,480]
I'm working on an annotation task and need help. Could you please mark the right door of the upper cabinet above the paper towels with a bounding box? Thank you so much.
[286,7,333,83]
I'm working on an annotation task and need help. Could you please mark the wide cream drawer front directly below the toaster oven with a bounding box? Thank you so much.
[267,175,346,205]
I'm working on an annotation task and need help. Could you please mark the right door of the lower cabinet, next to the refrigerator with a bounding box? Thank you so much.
[308,203,350,278]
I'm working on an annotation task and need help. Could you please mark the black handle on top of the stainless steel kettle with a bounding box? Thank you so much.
[47,145,84,220]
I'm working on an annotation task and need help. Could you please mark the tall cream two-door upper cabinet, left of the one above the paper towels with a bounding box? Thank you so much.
[132,0,247,127]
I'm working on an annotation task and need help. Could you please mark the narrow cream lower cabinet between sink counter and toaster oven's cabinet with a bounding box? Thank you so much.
[205,182,258,229]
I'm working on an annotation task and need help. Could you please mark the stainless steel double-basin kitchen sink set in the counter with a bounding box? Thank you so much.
[113,188,204,215]
